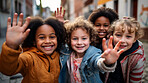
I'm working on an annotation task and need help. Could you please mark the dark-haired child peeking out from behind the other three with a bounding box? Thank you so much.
[88,7,118,51]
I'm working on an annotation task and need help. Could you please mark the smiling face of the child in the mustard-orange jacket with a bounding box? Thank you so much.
[35,24,57,55]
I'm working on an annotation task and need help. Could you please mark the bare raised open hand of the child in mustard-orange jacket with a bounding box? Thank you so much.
[6,13,30,49]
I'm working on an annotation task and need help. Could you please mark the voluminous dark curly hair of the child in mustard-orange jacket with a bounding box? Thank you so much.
[22,17,66,51]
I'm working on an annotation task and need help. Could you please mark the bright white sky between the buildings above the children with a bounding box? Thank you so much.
[36,0,61,11]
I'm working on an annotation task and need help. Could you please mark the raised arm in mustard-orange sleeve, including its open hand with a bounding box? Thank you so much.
[0,13,30,75]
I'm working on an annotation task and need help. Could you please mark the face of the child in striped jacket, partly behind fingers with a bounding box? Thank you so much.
[113,27,136,51]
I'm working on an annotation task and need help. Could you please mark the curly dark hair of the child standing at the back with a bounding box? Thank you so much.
[88,7,119,24]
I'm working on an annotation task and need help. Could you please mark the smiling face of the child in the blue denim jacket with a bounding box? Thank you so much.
[71,28,90,54]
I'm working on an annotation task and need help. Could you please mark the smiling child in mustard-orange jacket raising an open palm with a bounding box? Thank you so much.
[0,13,66,83]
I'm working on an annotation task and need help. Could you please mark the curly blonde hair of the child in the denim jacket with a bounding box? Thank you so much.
[65,16,97,47]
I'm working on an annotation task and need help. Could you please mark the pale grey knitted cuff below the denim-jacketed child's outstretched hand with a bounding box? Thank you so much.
[97,58,117,72]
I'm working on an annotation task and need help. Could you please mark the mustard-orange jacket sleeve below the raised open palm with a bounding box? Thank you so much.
[0,42,22,76]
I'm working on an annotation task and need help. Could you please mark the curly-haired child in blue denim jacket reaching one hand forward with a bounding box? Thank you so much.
[59,17,123,83]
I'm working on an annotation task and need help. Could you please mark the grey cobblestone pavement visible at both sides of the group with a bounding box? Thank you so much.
[0,38,148,83]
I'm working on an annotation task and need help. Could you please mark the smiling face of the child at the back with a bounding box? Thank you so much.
[94,16,110,38]
